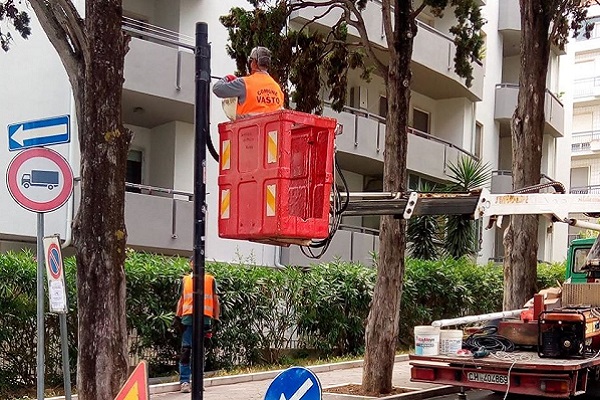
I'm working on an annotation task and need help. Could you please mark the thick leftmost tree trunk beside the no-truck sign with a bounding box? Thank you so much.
[71,0,131,400]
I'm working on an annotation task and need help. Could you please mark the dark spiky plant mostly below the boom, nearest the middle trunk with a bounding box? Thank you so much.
[406,183,441,260]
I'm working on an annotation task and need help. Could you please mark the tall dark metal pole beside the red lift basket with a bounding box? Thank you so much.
[192,22,210,400]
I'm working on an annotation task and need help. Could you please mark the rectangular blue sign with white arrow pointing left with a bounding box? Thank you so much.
[8,115,71,151]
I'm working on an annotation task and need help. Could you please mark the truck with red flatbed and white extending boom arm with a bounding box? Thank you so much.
[343,189,600,398]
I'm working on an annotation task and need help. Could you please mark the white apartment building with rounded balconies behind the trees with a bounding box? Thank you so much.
[0,0,570,265]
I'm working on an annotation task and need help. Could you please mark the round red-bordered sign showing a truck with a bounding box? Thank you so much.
[6,147,73,213]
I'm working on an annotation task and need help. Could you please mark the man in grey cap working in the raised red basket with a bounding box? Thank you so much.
[213,46,284,118]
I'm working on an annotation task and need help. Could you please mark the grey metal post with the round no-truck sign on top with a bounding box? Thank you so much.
[6,147,73,400]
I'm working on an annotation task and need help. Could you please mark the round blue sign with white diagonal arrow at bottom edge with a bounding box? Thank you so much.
[264,367,322,400]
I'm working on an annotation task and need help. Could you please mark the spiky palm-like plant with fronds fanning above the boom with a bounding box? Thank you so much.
[444,157,492,259]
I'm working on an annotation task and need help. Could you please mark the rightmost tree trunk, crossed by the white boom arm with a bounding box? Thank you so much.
[503,0,552,310]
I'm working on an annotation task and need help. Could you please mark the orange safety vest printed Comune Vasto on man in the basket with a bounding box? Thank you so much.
[237,72,284,115]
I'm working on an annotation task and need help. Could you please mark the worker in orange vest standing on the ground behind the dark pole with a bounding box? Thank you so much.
[176,259,221,393]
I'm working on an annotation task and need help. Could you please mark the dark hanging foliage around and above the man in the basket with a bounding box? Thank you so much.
[220,0,371,114]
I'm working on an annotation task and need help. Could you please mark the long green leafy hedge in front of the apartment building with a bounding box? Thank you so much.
[0,251,564,398]
